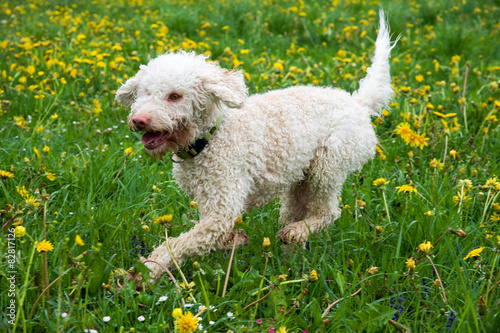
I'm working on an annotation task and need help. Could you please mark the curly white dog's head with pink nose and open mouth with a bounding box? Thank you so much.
[115,51,248,156]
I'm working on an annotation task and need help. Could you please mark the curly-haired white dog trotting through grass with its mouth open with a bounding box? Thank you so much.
[116,11,395,278]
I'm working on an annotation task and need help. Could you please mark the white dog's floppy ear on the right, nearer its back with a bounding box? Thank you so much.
[203,68,248,108]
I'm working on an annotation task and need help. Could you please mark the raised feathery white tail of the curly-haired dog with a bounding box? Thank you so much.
[353,9,399,114]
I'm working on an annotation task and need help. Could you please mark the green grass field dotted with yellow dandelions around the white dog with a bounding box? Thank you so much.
[0,0,500,333]
